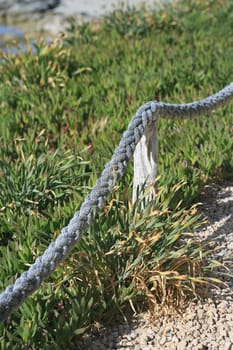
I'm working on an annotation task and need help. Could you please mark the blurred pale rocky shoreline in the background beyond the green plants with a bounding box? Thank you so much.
[0,0,171,42]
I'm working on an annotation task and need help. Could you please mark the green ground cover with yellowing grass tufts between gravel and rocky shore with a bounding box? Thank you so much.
[0,0,233,350]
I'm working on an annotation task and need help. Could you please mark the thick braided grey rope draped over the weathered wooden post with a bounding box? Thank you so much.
[0,83,233,321]
